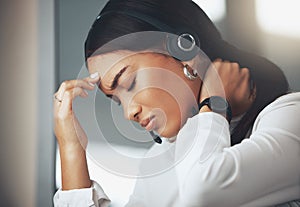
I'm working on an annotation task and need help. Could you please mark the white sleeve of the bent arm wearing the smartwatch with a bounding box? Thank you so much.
[175,100,300,206]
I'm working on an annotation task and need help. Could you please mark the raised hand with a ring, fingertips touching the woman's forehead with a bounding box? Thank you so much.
[53,74,99,148]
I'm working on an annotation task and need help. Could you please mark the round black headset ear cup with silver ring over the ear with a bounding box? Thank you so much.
[166,33,200,61]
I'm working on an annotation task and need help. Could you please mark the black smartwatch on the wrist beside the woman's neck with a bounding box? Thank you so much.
[198,96,232,123]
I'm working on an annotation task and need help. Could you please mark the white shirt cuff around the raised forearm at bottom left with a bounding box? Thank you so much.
[53,181,110,207]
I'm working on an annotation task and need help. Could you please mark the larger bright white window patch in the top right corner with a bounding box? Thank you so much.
[255,0,300,37]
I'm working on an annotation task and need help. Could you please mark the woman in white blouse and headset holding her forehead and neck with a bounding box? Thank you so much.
[54,0,300,206]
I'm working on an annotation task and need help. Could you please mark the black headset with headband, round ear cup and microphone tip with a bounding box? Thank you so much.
[96,10,200,144]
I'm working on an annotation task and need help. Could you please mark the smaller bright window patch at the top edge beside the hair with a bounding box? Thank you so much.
[194,0,226,22]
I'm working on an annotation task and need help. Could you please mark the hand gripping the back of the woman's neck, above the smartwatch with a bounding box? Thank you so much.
[199,59,255,116]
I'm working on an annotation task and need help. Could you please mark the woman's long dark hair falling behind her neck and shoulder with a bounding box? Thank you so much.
[85,0,288,145]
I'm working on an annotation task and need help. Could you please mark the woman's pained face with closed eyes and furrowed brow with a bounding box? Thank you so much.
[88,50,202,138]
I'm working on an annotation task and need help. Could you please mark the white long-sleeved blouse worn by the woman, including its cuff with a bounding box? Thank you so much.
[54,93,300,207]
